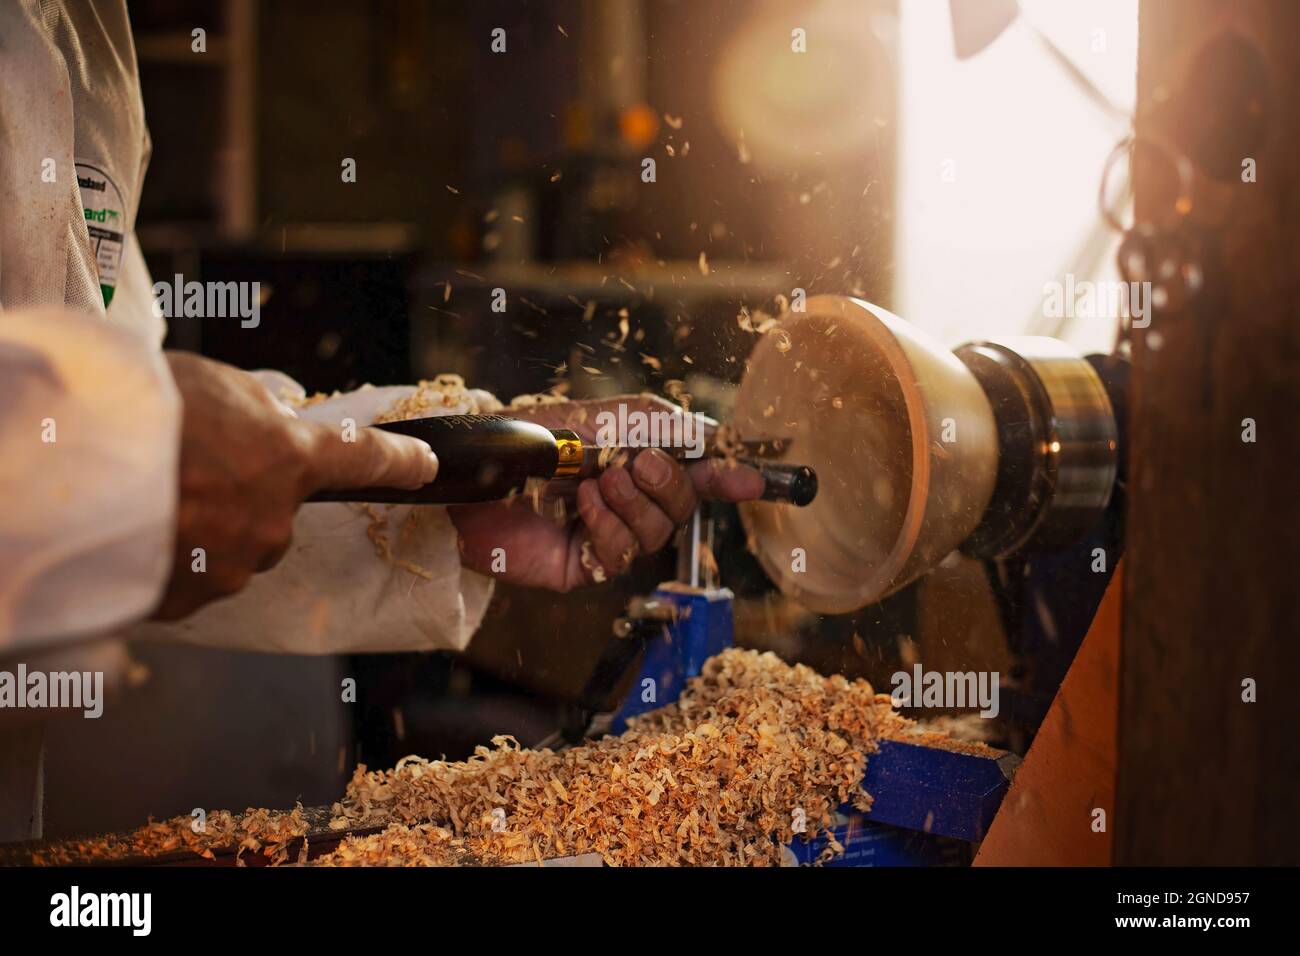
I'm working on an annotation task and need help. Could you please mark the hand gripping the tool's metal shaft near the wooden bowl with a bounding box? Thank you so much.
[449,395,763,591]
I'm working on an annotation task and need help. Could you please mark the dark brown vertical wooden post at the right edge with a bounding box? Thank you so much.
[1114,0,1300,865]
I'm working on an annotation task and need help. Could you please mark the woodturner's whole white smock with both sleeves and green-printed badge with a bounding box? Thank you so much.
[0,0,491,839]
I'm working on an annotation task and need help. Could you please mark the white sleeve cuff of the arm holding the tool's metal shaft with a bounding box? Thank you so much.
[133,385,493,654]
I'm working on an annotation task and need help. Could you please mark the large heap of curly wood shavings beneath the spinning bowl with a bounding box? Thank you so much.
[322,649,909,865]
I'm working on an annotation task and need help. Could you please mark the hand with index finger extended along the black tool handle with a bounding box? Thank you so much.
[155,352,438,620]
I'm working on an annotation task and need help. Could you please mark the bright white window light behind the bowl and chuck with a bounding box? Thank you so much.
[894,0,1138,351]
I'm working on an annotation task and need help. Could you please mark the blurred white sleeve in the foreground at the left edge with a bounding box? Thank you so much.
[0,307,181,656]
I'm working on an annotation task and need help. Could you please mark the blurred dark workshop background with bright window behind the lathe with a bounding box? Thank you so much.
[46,0,1138,836]
